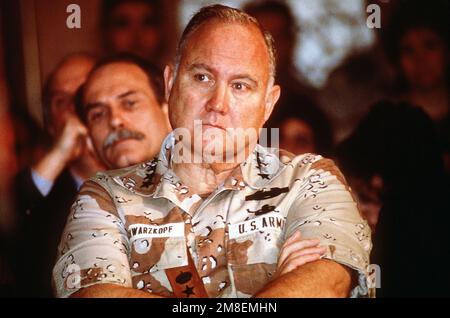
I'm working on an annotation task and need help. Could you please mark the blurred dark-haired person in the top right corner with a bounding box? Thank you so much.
[385,0,450,174]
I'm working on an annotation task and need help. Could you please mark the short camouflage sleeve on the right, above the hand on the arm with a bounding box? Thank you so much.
[286,159,372,297]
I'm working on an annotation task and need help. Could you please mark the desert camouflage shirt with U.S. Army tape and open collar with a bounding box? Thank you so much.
[53,135,372,297]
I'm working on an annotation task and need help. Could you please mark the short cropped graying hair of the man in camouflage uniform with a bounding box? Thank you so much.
[175,4,276,83]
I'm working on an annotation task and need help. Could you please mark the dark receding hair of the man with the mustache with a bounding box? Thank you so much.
[75,53,165,122]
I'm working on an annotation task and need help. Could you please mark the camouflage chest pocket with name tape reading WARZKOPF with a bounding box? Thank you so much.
[129,223,188,273]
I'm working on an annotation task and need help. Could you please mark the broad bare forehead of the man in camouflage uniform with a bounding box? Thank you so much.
[182,21,270,77]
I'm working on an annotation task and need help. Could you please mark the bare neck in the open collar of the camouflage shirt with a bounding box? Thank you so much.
[172,163,240,196]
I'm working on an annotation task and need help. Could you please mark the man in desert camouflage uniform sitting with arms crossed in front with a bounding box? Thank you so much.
[53,5,371,298]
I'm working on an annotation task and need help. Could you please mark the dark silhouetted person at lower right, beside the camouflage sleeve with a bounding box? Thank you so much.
[337,101,450,297]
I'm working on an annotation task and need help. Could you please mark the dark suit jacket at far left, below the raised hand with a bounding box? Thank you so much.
[12,169,78,297]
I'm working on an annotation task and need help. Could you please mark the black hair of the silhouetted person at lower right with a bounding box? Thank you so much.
[336,100,443,191]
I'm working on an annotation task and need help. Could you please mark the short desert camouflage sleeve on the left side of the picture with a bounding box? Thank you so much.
[52,181,131,297]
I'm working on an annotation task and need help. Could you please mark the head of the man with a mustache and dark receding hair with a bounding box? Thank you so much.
[77,54,171,169]
